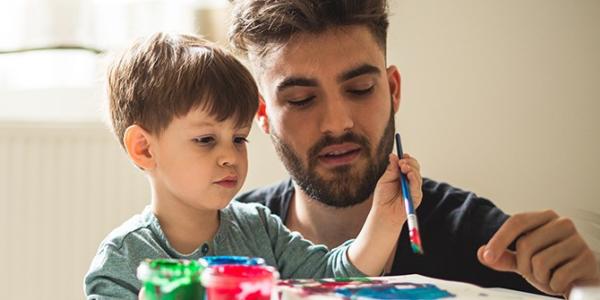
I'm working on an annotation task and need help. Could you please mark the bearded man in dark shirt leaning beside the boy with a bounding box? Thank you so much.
[231,0,600,295]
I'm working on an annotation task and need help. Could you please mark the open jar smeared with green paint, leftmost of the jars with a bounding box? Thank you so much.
[137,259,206,300]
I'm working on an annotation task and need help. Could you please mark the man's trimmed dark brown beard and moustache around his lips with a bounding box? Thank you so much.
[270,110,395,208]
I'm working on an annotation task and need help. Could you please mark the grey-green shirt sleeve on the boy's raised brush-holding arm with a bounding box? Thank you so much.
[259,207,365,279]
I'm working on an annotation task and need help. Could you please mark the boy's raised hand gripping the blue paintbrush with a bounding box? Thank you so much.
[373,153,423,224]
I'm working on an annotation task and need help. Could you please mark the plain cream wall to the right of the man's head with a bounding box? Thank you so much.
[388,0,600,249]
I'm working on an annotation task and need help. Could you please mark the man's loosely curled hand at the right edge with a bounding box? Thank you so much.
[477,210,600,295]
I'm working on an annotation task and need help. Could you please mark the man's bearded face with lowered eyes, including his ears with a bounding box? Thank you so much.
[257,26,400,207]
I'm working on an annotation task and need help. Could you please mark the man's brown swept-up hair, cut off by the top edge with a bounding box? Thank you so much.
[229,0,389,57]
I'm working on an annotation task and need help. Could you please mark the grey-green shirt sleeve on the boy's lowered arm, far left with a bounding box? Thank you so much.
[84,246,140,300]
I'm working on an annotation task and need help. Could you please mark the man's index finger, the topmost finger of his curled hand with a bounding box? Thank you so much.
[483,210,558,263]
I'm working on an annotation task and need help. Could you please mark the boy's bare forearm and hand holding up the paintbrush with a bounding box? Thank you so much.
[348,154,423,276]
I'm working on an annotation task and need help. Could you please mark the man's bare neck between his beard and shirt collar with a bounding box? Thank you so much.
[285,184,373,249]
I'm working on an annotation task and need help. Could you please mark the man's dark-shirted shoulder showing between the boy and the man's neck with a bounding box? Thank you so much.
[235,178,294,219]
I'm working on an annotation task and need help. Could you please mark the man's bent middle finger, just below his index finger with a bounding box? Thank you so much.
[516,218,576,283]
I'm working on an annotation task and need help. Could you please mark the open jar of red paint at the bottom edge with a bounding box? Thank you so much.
[202,265,279,300]
